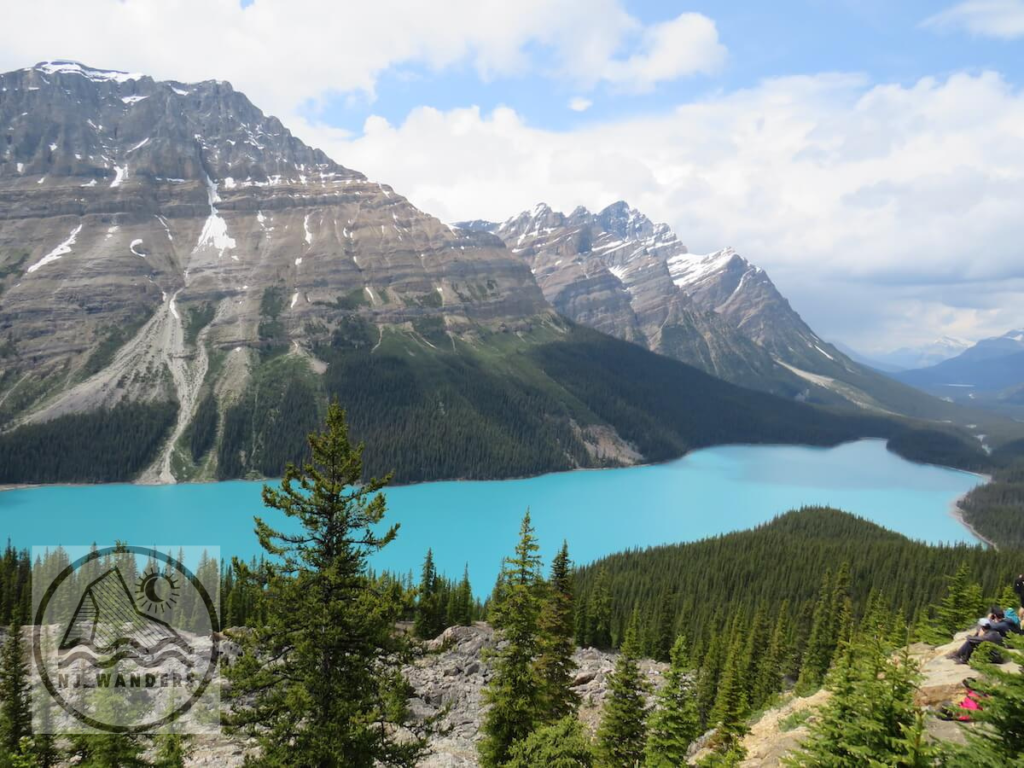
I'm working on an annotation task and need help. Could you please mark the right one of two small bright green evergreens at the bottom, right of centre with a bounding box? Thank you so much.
[646,635,700,768]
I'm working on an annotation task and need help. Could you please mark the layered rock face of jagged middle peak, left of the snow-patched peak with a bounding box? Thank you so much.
[479,203,807,396]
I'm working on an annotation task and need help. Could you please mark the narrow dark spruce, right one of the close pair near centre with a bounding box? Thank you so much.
[536,542,580,723]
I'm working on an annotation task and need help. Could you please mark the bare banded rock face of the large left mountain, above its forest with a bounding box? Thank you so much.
[0,62,551,479]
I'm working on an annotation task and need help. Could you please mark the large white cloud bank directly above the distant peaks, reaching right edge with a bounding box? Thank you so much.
[321,73,1024,346]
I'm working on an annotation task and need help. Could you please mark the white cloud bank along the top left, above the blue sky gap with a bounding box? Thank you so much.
[0,0,722,118]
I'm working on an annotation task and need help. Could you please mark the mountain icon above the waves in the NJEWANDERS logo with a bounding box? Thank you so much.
[57,566,193,669]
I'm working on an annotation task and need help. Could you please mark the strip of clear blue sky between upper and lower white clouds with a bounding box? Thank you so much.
[301,0,1024,133]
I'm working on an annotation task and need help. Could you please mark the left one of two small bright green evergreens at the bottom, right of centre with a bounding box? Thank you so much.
[597,613,648,768]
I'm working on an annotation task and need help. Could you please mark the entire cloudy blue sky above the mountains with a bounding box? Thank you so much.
[0,0,1024,353]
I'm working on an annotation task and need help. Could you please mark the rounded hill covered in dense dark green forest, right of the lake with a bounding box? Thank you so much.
[578,508,1021,654]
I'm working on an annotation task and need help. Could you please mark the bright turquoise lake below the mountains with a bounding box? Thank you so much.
[0,440,982,594]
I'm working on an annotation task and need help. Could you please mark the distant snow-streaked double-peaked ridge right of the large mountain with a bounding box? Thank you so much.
[455,201,970,419]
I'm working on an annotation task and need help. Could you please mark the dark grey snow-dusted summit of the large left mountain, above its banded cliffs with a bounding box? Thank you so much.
[0,60,365,195]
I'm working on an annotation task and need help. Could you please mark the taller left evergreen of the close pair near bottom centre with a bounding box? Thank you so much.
[479,510,542,768]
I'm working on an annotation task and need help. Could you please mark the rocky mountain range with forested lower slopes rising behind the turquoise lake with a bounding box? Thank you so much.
[0,61,999,482]
